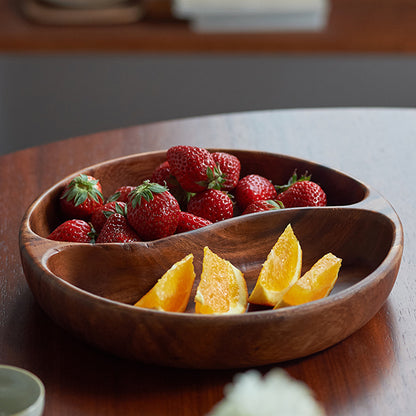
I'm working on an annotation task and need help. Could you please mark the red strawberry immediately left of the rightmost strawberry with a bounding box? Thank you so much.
[235,174,277,210]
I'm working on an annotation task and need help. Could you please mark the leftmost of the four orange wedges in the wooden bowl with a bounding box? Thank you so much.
[134,254,195,312]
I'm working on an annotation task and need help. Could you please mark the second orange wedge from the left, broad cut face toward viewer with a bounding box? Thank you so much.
[195,247,248,314]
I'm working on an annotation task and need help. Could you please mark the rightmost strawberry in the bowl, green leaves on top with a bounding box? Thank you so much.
[277,172,326,208]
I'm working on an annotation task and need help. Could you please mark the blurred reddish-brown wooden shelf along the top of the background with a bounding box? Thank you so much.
[0,0,416,53]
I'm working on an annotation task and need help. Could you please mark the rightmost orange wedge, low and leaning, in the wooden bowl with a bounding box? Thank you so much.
[277,253,342,306]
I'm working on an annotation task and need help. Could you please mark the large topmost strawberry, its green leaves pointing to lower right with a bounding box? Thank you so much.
[167,146,224,192]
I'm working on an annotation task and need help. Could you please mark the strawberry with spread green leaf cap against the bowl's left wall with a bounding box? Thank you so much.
[60,174,104,220]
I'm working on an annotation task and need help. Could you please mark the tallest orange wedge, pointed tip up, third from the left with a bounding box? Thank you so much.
[248,224,302,306]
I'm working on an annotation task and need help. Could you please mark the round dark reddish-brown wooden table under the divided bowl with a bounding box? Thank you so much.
[0,109,416,416]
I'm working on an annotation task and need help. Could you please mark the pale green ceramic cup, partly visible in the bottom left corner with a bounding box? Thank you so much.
[0,365,45,416]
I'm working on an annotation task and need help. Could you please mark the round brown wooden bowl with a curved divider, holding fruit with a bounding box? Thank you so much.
[20,150,403,368]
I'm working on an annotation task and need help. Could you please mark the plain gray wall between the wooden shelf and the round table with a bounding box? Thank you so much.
[0,54,416,154]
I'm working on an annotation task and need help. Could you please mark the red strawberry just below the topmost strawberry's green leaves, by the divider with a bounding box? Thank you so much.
[188,189,233,222]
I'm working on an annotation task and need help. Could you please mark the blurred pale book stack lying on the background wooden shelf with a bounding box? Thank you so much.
[172,0,330,32]
